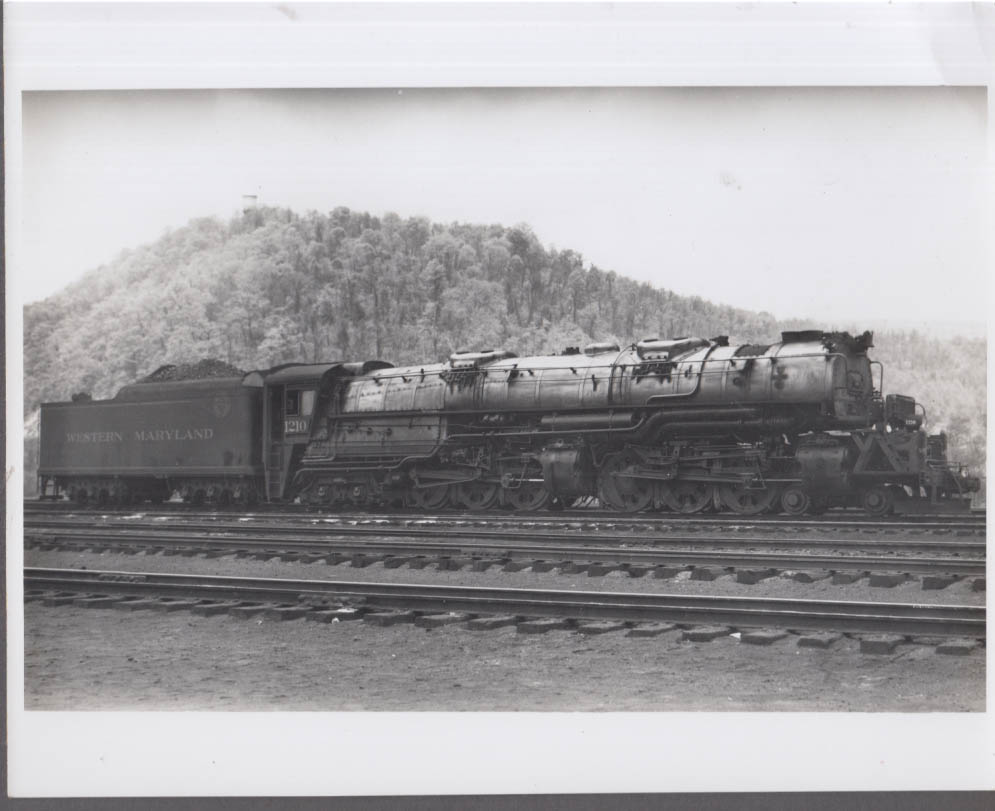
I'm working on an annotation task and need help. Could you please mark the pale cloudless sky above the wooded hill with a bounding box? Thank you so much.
[14,87,988,329]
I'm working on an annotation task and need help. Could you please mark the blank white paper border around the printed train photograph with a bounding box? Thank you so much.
[4,3,995,797]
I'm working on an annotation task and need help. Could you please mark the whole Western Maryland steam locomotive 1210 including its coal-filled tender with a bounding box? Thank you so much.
[39,331,979,516]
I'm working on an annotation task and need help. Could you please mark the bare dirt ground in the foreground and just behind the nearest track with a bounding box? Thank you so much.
[25,551,985,712]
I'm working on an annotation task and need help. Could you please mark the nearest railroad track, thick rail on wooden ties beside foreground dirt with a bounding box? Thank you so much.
[24,568,985,639]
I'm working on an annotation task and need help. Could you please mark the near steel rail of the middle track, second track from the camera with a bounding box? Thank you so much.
[23,532,985,577]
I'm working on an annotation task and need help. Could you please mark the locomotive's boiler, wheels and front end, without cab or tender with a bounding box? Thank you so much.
[294,331,977,515]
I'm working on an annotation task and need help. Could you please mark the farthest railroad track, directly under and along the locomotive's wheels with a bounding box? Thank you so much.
[24,500,986,533]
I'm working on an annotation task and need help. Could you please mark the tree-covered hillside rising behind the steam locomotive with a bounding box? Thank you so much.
[24,208,986,492]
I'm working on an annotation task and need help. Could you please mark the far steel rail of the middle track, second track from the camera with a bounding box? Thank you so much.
[25,520,985,555]
